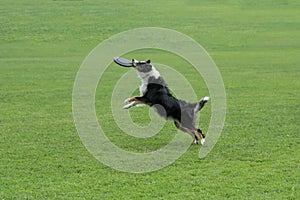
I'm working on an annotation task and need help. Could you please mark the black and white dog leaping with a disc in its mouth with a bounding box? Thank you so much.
[124,59,209,145]
